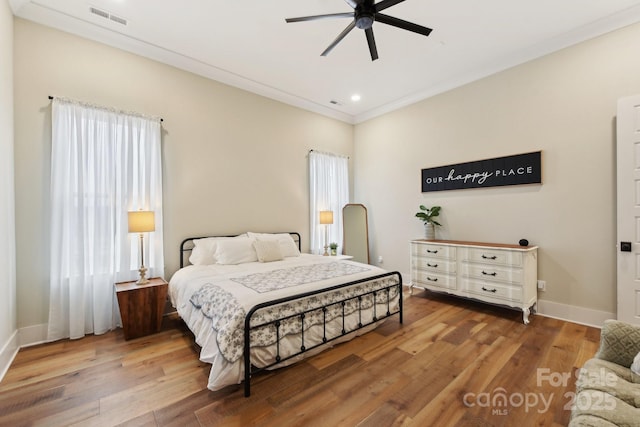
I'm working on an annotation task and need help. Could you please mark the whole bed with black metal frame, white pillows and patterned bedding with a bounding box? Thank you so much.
[169,232,402,397]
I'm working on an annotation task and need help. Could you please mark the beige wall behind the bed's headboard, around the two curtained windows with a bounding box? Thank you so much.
[15,19,353,328]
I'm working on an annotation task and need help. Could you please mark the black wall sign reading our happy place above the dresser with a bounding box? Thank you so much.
[421,151,542,193]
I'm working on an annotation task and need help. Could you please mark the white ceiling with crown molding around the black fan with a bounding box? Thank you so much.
[9,0,640,123]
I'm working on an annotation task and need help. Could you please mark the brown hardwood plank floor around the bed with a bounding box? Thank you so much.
[0,290,600,427]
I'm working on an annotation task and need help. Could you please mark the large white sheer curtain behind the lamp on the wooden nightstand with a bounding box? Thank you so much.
[47,98,164,341]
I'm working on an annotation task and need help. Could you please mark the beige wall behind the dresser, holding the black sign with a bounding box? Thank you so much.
[354,20,640,317]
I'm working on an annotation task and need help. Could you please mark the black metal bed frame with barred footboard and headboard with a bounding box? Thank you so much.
[180,232,403,397]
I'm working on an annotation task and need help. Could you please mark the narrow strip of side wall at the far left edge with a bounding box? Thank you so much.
[0,0,17,368]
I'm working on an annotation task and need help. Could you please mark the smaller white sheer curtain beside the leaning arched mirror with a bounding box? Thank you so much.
[309,151,349,254]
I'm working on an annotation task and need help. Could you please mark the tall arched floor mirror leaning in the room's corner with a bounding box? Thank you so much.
[342,203,369,264]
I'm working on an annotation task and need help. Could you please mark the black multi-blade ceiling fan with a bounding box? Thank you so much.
[285,0,432,61]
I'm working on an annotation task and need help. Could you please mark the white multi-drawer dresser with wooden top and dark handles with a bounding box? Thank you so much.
[410,240,538,324]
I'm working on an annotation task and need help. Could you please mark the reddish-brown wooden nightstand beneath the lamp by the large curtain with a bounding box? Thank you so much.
[115,277,169,340]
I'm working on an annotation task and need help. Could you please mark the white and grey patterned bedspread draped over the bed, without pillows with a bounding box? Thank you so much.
[169,254,398,390]
